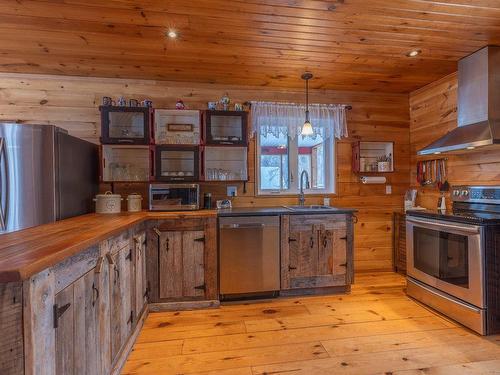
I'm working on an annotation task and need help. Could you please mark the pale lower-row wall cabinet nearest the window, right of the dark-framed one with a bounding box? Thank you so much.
[204,146,248,181]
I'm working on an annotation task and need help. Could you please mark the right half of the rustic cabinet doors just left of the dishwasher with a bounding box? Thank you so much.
[182,231,206,298]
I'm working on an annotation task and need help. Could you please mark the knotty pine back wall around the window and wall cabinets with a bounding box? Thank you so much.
[0,73,410,271]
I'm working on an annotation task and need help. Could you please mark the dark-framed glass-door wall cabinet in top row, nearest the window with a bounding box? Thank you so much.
[204,111,248,146]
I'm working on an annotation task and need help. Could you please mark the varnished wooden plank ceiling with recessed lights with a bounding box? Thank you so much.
[0,0,500,92]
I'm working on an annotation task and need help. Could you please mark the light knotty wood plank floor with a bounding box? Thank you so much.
[122,273,500,375]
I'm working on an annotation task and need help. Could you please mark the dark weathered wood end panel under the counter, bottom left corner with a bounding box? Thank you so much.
[0,283,24,375]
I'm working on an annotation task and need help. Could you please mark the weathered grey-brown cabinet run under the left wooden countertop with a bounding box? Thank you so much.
[7,225,147,375]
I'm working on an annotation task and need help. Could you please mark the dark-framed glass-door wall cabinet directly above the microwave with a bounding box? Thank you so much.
[155,146,199,181]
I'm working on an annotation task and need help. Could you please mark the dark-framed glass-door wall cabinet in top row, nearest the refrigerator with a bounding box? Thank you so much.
[99,106,153,145]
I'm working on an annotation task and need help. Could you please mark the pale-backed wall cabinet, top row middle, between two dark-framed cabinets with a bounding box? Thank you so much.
[155,109,201,145]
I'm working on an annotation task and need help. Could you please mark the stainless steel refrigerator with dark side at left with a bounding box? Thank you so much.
[0,123,98,234]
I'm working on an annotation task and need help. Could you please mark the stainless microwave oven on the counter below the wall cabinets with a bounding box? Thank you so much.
[149,184,200,211]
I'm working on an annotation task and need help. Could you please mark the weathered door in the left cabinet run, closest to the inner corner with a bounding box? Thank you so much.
[109,246,133,363]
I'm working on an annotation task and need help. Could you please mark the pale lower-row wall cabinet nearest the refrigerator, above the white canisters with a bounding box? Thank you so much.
[102,145,151,182]
